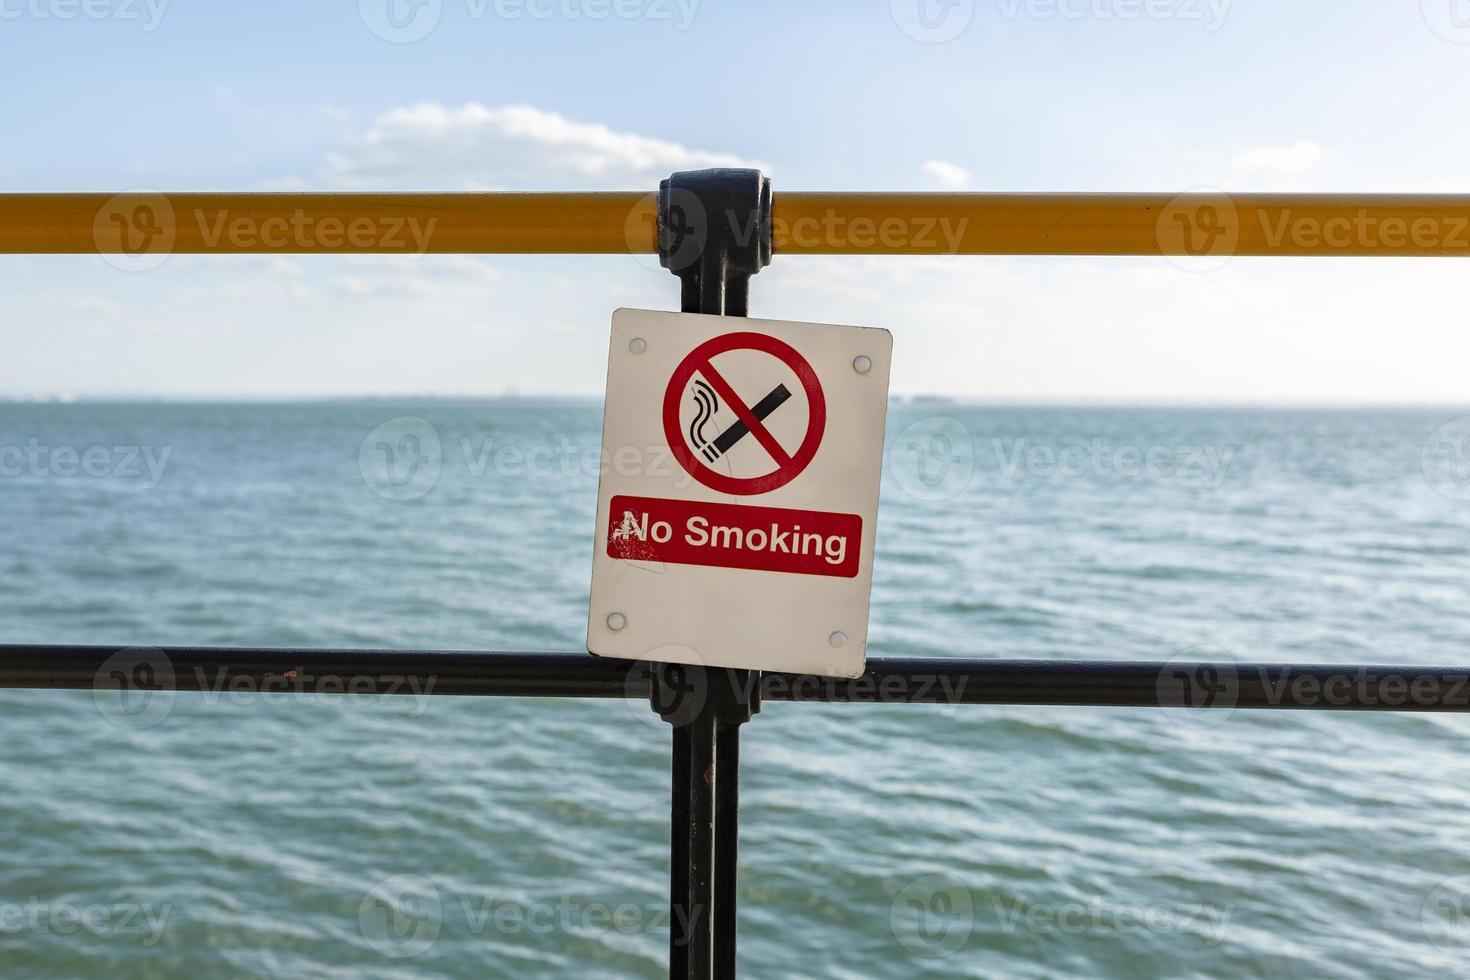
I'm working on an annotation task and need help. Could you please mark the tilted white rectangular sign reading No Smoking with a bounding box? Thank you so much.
[587,310,894,677]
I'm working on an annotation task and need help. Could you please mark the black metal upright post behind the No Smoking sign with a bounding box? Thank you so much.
[653,170,772,980]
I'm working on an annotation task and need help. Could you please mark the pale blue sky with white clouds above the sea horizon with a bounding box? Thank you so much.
[0,0,1470,404]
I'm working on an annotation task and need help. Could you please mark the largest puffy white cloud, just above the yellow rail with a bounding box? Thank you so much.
[328,103,761,190]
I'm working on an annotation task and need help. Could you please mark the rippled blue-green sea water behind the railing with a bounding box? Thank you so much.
[0,401,1470,980]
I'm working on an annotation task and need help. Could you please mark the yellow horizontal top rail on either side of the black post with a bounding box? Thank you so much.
[0,191,1470,256]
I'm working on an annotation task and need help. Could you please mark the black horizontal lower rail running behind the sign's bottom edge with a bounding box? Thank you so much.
[0,645,1470,720]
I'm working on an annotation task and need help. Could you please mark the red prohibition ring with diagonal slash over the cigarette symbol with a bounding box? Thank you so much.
[663,332,826,497]
